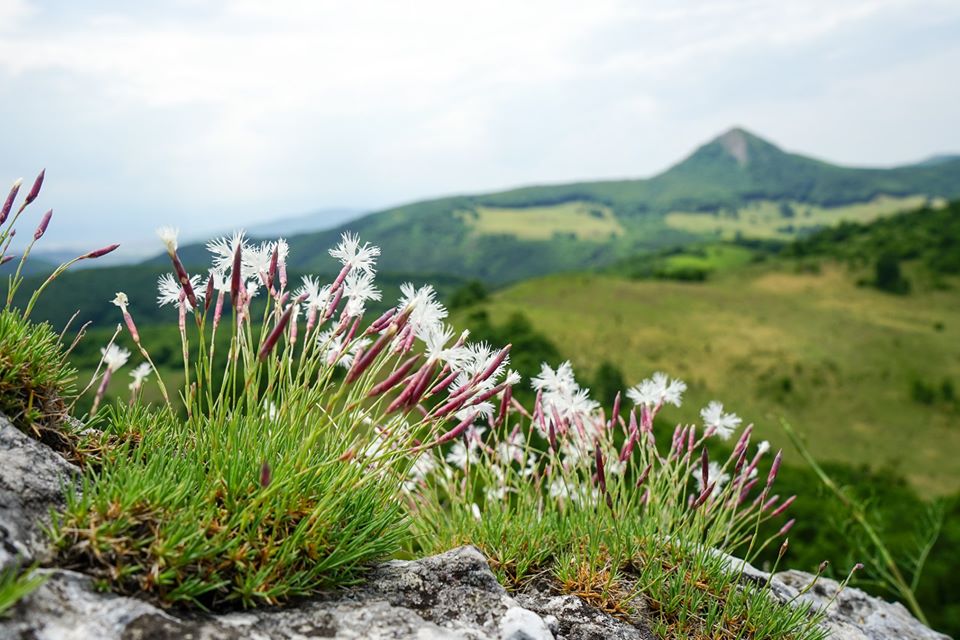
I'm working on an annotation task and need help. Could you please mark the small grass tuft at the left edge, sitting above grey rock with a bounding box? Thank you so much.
[0,309,76,445]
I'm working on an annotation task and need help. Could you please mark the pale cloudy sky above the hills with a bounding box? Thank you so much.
[0,0,960,255]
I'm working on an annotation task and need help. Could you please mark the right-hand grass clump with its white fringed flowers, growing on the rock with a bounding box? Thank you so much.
[412,365,825,640]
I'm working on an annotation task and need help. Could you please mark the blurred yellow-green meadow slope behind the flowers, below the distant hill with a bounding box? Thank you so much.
[460,266,960,494]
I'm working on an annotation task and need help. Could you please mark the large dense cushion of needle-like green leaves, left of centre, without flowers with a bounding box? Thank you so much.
[53,407,406,607]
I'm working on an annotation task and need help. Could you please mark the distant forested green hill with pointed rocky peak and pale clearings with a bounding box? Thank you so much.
[165,129,960,283]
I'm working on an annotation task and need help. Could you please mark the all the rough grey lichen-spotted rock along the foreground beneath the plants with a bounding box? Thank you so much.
[0,416,946,640]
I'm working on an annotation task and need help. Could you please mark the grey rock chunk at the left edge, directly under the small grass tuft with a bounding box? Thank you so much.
[0,415,77,570]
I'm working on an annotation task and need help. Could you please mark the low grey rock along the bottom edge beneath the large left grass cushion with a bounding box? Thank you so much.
[0,547,554,640]
